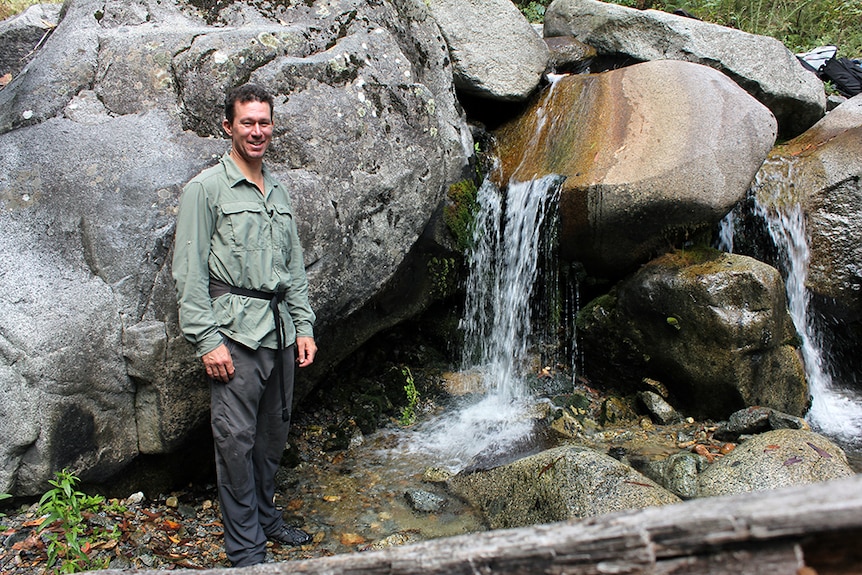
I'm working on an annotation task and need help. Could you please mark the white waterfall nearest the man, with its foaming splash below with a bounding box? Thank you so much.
[410,176,562,471]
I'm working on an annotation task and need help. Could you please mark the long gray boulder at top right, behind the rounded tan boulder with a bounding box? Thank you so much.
[545,0,826,137]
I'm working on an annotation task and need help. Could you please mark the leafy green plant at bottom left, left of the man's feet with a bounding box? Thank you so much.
[39,469,112,573]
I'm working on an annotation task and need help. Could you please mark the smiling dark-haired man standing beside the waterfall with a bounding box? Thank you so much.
[173,84,317,567]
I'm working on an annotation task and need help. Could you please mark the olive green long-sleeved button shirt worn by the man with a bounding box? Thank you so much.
[173,154,315,356]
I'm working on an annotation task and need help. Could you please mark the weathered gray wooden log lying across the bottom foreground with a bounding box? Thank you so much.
[93,475,862,575]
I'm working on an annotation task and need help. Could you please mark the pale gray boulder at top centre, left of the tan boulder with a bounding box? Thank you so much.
[428,0,549,101]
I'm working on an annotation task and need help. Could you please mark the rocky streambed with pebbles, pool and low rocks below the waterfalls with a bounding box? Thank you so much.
[0,368,860,575]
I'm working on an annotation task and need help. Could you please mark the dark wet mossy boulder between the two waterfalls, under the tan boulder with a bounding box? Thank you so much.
[578,249,808,419]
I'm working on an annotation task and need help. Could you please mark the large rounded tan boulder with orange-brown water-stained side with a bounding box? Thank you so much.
[495,60,776,279]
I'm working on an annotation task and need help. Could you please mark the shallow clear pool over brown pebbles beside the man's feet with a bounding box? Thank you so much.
[277,428,486,555]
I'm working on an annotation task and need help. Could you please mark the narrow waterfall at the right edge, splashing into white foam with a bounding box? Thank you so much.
[748,159,862,445]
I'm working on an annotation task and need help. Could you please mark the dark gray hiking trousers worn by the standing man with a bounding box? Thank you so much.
[210,340,295,567]
